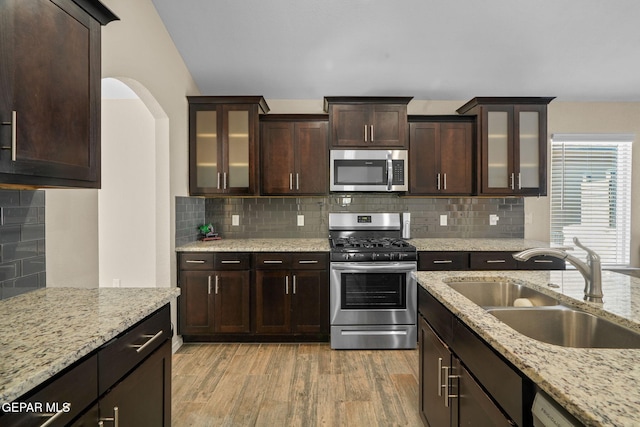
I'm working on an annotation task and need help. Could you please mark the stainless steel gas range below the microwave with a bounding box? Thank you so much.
[329,213,418,349]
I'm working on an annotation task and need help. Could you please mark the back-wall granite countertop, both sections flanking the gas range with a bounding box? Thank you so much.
[176,238,549,252]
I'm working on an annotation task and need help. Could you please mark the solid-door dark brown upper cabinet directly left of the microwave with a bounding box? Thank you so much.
[260,115,329,195]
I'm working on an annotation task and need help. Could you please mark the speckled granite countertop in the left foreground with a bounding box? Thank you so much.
[0,288,180,404]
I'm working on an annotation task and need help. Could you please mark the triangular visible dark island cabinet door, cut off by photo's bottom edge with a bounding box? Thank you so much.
[451,357,515,427]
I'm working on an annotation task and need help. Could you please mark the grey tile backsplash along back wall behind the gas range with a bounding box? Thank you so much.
[176,194,524,242]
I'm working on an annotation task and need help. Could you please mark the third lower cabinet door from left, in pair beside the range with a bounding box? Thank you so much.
[255,270,292,334]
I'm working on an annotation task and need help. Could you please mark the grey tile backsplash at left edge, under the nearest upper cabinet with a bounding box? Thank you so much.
[0,190,46,299]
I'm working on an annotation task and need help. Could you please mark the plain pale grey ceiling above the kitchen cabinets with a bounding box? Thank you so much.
[152,0,640,101]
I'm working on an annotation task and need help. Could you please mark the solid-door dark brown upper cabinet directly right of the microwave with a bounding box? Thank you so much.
[409,116,475,196]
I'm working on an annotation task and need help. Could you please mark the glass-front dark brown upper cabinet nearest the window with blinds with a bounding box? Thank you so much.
[457,97,554,196]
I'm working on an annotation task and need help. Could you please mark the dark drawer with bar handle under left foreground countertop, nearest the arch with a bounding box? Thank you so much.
[98,304,171,394]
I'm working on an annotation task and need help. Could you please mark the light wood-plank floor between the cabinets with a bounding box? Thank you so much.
[172,343,422,427]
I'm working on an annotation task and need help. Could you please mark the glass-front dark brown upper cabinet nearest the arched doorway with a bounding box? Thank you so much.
[187,96,269,196]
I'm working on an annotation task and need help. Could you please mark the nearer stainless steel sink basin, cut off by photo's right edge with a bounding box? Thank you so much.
[487,305,640,348]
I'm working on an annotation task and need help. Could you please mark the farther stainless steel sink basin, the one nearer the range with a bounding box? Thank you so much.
[447,281,558,307]
